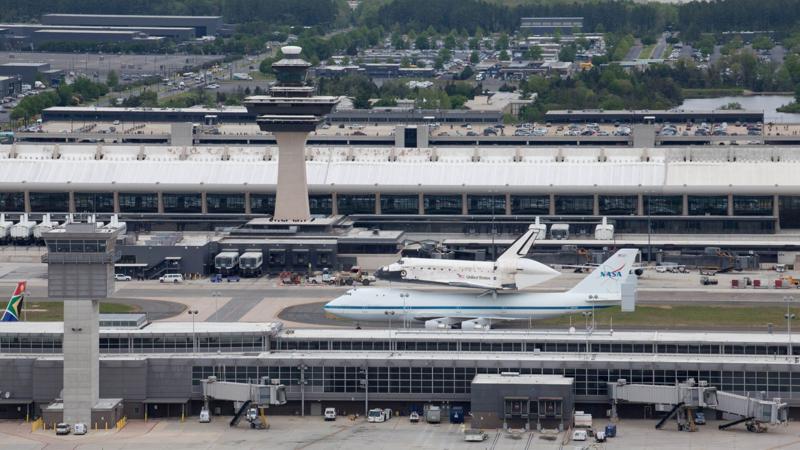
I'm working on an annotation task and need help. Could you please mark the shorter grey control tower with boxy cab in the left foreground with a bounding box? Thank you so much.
[42,223,120,425]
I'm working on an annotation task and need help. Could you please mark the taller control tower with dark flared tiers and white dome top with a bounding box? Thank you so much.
[245,46,339,221]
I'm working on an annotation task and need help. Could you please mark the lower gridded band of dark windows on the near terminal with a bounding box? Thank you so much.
[192,361,800,397]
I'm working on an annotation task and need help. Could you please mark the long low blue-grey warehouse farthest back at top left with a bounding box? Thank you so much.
[41,14,223,37]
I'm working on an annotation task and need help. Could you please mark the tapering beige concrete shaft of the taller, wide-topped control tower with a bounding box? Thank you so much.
[273,131,311,221]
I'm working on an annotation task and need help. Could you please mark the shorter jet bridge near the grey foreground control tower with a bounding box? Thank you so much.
[202,376,286,429]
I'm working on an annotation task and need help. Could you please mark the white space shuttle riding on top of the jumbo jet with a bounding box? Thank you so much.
[375,226,561,290]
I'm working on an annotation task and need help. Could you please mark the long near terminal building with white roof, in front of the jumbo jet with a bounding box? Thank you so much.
[0,324,800,425]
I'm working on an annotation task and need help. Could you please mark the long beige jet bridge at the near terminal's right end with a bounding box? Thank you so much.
[608,379,788,432]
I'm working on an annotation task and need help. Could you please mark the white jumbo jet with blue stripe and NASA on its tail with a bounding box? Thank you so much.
[324,249,639,330]
